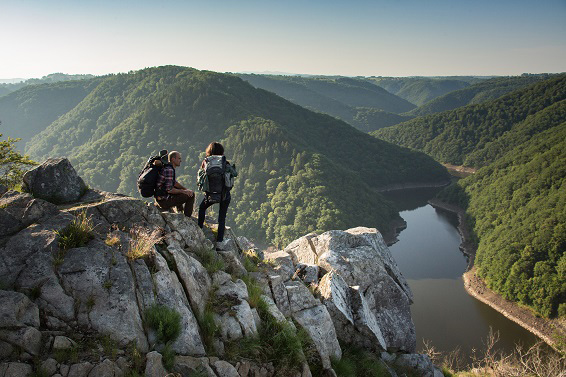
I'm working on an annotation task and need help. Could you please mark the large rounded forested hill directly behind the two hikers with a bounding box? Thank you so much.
[0,66,448,245]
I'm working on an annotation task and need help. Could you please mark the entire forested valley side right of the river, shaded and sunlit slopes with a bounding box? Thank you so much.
[375,74,566,317]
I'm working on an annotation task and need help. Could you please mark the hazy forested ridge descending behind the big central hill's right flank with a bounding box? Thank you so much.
[239,74,415,132]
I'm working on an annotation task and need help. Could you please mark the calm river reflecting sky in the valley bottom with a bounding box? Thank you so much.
[385,188,537,363]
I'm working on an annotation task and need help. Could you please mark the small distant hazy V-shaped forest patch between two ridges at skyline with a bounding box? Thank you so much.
[368,77,474,106]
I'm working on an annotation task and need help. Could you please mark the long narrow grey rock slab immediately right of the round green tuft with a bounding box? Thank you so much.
[153,254,205,355]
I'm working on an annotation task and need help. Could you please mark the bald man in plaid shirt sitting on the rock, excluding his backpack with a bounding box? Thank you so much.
[155,151,195,217]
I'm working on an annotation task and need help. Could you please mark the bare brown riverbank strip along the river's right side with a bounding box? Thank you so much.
[429,199,566,352]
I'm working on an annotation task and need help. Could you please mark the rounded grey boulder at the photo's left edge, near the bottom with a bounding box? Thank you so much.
[0,290,39,328]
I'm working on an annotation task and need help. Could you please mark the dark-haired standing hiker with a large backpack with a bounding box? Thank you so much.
[197,142,238,249]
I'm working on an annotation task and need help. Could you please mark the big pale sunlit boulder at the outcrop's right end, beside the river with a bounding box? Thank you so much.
[285,228,416,352]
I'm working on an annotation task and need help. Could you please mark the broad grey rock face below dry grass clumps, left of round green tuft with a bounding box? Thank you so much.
[59,240,148,352]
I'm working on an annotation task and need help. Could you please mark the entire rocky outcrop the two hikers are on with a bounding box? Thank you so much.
[0,159,435,377]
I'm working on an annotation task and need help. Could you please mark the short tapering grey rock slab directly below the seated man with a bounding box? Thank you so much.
[167,246,212,314]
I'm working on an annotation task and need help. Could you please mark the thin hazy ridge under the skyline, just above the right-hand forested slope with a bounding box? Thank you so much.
[407,74,551,116]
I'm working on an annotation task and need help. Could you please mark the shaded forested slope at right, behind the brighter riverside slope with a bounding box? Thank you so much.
[372,74,566,166]
